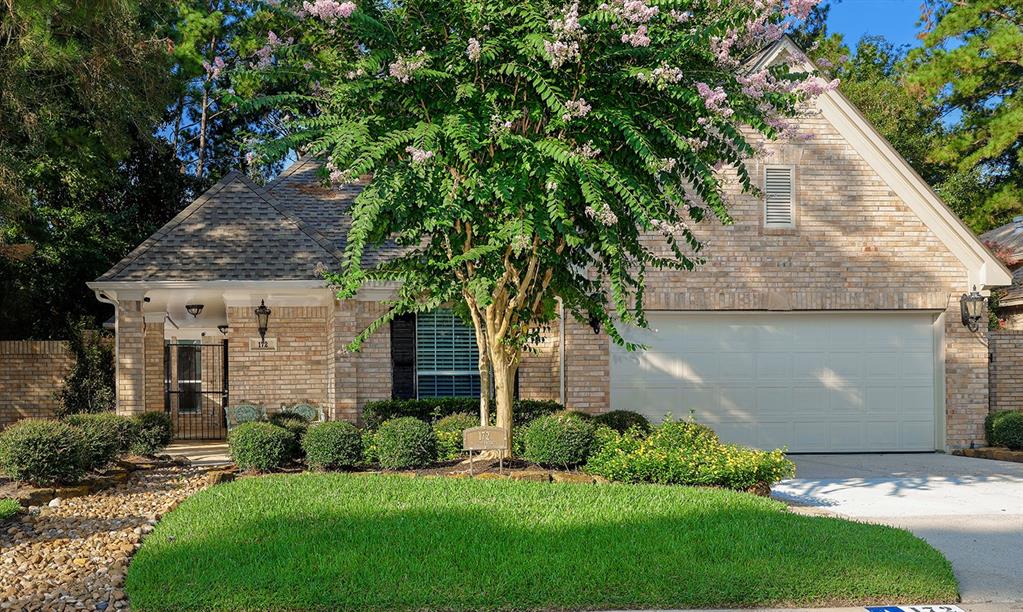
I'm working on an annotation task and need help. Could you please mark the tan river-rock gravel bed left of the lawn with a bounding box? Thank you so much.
[0,467,207,610]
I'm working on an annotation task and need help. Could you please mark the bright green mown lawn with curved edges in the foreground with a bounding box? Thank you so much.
[127,474,957,610]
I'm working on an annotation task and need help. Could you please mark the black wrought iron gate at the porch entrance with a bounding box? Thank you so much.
[164,340,227,440]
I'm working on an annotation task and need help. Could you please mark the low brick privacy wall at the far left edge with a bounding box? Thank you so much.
[0,340,75,430]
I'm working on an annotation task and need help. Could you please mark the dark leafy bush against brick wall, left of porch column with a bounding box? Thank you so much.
[57,317,114,417]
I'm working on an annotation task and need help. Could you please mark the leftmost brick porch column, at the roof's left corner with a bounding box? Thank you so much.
[116,299,145,416]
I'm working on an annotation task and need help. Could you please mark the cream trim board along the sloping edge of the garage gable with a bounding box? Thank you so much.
[753,37,1012,290]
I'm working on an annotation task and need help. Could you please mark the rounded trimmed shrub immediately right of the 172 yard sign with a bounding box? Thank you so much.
[524,411,596,468]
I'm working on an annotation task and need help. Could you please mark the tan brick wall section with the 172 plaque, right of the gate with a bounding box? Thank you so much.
[227,305,330,412]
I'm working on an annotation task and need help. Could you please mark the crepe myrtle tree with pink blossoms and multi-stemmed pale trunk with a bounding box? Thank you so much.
[250,0,837,448]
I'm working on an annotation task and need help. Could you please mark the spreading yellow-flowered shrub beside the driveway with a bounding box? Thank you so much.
[585,420,796,490]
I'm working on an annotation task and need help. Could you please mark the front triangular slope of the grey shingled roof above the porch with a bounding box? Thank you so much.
[97,171,341,281]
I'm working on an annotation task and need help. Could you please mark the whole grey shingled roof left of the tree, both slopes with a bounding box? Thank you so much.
[97,159,396,281]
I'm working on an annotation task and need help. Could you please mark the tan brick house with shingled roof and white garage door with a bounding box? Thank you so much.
[90,40,1011,451]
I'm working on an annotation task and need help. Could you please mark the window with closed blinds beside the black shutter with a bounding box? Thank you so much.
[415,308,480,397]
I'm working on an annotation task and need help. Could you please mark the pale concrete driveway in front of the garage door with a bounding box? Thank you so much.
[773,453,1023,603]
